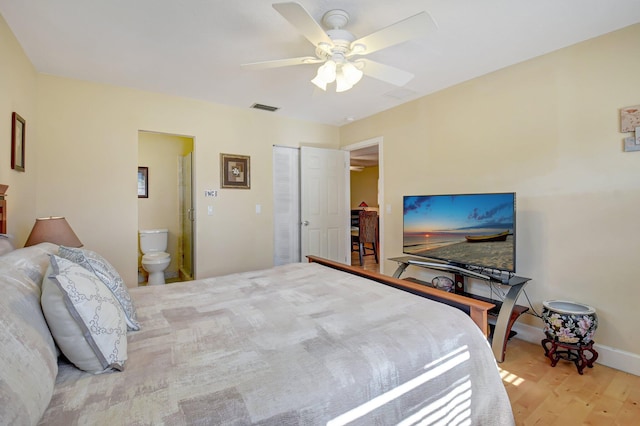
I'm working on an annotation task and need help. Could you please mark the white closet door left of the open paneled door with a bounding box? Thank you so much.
[273,146,300,265]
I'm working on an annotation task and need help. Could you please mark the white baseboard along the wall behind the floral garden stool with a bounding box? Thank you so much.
[506,323,640,376]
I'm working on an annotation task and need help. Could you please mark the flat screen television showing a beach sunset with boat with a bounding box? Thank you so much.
[402,192,516,272]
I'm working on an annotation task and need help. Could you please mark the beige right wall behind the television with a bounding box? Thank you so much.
[340,25,640,354]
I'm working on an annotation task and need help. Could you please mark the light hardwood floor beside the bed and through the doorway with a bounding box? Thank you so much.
[351,252,640,426]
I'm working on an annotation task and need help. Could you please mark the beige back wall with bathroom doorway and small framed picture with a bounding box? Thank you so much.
[32,75,338,285]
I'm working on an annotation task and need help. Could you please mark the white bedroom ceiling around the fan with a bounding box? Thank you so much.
[0,0,640,125]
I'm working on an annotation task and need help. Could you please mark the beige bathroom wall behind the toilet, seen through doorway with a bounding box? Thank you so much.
[138,132,193,277]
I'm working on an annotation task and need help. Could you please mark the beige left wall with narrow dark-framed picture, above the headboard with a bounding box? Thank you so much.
[0,15,39,241]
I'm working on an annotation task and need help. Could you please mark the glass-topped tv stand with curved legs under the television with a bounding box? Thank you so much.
[389,256,531,362]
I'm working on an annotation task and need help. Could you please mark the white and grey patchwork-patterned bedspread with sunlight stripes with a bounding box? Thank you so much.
[41,263,513,425]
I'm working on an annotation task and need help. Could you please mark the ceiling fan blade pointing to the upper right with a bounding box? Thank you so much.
[351,12,438,55]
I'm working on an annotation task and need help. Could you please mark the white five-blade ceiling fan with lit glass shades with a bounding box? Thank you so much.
[242,2,437,92]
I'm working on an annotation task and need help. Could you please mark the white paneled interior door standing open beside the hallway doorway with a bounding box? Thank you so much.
[300,147,351,264]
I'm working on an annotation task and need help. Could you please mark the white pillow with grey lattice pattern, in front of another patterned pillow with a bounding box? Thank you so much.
[41,255,127,374]
